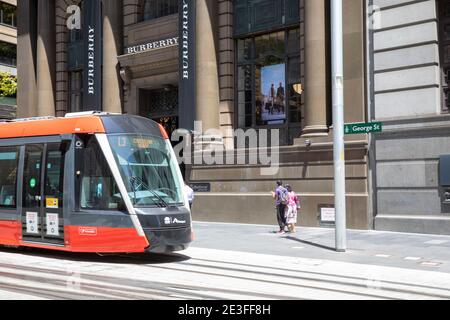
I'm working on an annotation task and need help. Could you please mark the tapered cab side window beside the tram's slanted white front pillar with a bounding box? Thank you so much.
[80,137,125,211]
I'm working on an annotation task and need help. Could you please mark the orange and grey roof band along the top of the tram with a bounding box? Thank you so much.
[0,113,165,139]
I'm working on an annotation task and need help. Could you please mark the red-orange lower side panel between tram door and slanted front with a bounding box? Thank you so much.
[65,226,149,253]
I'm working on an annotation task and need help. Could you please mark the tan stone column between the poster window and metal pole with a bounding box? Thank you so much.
[302,0,329,137]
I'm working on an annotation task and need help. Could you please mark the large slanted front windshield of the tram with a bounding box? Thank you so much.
[108,134,184,207]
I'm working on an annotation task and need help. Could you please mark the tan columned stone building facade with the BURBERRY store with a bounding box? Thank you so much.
[18,0,373,229]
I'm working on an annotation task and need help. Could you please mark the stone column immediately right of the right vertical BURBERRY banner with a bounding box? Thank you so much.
[196,0,220,144]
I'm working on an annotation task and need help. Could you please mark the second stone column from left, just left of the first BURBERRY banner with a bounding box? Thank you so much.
[36,0,56,117]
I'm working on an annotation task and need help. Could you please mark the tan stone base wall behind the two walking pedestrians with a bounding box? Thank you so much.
[191,141,373,230]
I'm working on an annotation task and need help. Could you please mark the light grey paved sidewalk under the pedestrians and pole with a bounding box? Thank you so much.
[192,222,450,273]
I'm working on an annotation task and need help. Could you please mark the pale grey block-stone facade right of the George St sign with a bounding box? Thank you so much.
[367,0,450,234]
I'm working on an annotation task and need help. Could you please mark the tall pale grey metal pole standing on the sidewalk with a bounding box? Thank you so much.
[330,0,347,252]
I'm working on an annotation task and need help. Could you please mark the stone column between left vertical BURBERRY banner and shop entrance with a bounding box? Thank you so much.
[102,0,123,113]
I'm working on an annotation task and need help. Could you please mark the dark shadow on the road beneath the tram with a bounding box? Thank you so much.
[0,247,191,265]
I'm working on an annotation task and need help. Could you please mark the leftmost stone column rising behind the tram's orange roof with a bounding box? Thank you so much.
[17,0,37,118]
